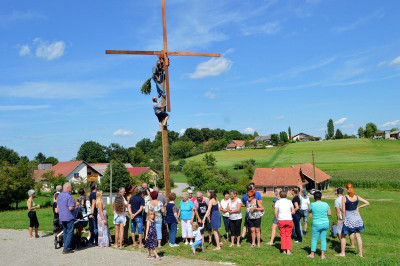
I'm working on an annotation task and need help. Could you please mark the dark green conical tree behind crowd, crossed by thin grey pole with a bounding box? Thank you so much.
[100,160,134,192]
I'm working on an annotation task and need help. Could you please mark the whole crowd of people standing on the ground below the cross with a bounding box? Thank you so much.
[28,183,369,259]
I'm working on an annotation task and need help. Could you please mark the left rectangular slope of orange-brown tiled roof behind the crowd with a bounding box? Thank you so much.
[253,167,302,187]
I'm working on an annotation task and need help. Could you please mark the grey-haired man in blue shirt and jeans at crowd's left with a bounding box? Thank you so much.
[57,183,75,254]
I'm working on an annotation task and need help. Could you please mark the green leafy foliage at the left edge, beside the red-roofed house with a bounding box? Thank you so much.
[0,159,35,210]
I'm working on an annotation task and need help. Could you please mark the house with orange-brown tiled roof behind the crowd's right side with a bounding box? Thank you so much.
[253,163,331,196]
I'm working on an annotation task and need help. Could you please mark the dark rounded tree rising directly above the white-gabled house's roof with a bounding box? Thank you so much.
[76,141,107,163]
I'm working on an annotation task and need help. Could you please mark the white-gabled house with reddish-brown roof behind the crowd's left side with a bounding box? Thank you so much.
[33,161,103,183]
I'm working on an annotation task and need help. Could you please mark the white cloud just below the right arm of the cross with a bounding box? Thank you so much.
[189,57,233,79]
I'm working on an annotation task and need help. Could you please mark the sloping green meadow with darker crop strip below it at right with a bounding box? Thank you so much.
[176,139,400,189]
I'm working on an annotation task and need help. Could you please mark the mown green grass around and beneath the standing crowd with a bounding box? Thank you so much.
[0,189,400,265]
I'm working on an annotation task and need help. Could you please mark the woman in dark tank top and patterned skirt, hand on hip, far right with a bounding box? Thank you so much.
[337,183,369,257]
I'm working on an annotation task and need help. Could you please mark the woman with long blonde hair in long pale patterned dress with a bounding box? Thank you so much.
[96,191,111,247]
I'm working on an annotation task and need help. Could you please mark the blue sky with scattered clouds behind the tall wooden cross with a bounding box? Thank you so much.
[0,0,400,160]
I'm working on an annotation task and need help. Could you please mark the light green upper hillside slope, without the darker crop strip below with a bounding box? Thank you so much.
[180,139,400,171]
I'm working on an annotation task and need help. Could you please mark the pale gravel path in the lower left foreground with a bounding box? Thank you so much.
[0,229,219,266]
